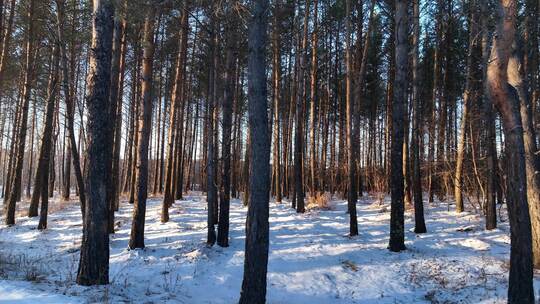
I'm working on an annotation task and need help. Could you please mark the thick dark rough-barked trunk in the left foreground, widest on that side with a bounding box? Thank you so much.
[77,0,114,285]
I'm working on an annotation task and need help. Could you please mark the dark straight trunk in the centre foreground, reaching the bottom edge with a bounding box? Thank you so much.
[239,0,270,304]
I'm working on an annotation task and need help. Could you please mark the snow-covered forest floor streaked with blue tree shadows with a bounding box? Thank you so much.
[0,193,540,304]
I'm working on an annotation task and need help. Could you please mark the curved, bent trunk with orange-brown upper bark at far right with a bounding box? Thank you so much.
[487,0,534,303]
